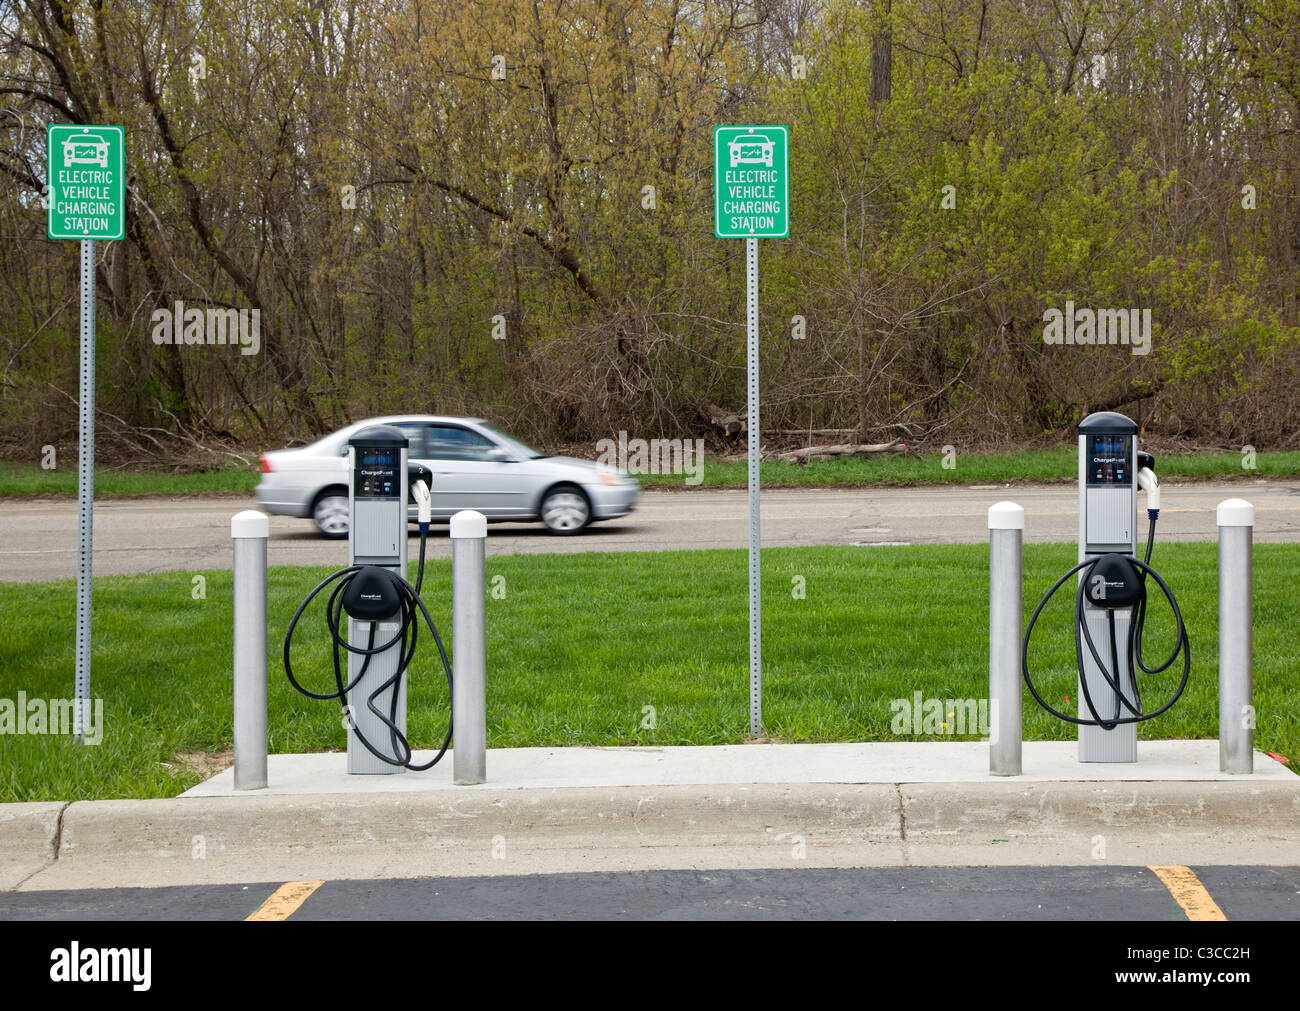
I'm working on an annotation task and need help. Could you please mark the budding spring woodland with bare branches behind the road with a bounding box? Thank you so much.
[0,0,1300,450]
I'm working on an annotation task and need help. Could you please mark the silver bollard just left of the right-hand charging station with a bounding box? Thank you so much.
[988,502,1024,776]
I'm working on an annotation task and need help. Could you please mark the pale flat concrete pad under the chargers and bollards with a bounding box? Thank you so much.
[182,741,1300,798]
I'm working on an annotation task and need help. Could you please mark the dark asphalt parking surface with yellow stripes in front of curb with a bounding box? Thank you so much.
[0,865,1300,920]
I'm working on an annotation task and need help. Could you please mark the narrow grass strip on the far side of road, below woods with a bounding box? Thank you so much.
[0,447,1300,498]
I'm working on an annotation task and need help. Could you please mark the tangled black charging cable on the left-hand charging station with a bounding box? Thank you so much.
[285,522,451,772]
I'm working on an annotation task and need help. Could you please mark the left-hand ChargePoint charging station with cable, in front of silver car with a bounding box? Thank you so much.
[285,425,451,774]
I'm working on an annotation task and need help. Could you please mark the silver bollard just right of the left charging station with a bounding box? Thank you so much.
[451,509,488,786]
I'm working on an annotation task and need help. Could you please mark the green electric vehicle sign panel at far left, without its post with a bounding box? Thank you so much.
[46,125,126,239]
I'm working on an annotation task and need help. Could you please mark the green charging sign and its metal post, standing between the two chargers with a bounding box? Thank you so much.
[714,126,790,737]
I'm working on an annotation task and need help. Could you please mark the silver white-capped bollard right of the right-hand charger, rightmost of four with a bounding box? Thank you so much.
[1217,499,1255,773]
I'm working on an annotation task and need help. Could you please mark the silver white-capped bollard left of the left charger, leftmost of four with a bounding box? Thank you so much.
[230,509,268,790]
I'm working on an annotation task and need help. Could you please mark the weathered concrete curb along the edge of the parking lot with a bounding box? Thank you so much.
[10,781,1300,890]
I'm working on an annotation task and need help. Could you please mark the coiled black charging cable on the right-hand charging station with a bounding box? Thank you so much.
[1021,509,1192,730]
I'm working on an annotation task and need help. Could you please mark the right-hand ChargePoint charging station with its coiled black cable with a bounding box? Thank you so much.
[1022,411,1191,761]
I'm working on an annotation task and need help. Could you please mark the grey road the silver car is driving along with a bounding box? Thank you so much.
[0,480,1300,582]
